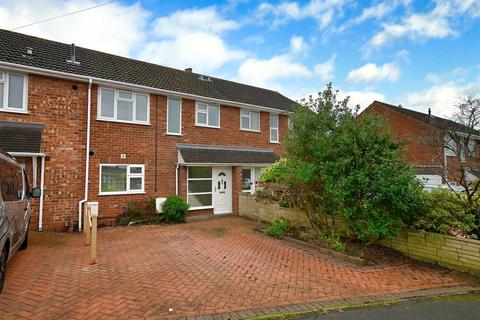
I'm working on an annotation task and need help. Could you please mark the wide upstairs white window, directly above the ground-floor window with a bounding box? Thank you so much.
[97,88,150,124]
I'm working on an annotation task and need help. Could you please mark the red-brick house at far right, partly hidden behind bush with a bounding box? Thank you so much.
[359,101,480,190]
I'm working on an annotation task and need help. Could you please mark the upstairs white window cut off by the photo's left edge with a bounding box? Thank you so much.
[0,71,28,113]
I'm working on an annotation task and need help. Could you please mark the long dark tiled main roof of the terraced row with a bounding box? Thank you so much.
[0,29,295,111]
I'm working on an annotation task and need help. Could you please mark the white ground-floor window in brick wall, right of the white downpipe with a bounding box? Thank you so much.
[99,164,145,195]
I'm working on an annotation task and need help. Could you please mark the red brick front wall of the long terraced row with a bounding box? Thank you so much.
[0,74,287,230]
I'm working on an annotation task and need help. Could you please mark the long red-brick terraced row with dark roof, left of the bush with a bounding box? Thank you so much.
[0,30,294,230]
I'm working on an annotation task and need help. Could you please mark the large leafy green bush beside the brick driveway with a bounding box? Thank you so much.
[262,85,423,241]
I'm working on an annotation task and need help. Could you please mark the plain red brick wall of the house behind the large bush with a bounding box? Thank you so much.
[362,102,443,170]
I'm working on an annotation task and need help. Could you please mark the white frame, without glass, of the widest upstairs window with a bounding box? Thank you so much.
[97,87,150,125]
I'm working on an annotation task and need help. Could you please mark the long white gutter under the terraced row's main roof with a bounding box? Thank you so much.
[0,61,293,115]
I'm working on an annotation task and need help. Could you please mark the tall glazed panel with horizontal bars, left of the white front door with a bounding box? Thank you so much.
[187,167,213,210]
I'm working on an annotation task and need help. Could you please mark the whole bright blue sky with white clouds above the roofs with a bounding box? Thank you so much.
[0,0,480,116]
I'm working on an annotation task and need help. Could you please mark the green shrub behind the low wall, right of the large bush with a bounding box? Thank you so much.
[412,189,475,236]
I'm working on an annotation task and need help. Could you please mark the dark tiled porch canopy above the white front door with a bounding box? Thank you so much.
[177,144,276,164]
